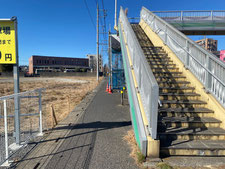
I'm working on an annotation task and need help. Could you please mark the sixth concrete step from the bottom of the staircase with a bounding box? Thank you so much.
[159,93,200,100]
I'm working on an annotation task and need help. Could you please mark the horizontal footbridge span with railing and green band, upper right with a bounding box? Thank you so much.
[153,11,225,35]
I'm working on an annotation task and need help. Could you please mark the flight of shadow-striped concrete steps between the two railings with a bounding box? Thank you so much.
[132,24,225,156]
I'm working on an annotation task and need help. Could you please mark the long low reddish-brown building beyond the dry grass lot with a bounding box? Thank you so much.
[29,55,89,74]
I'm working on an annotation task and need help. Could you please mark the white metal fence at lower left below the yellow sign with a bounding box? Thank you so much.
[0,88,45,165]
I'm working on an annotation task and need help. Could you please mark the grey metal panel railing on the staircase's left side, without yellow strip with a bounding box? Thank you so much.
[120,8,159,142]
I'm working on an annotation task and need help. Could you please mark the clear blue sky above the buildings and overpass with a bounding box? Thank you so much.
[0,0,225,65]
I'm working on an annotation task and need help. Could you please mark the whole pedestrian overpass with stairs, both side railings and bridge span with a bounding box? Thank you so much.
[118,7,225,157]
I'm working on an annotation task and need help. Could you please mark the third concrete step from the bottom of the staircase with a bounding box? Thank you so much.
[158,117,221,129]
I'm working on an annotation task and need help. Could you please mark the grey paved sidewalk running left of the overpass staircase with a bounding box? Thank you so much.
[14,81,138,169]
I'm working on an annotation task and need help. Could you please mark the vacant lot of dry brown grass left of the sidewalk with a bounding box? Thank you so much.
[0,77,100,127]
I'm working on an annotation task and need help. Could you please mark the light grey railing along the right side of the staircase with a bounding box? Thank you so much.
[140,7,225,107]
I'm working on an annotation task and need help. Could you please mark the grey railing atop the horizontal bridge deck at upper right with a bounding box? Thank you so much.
[153,10,225,22]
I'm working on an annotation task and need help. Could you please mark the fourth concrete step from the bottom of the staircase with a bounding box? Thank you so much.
[159,107,214,117]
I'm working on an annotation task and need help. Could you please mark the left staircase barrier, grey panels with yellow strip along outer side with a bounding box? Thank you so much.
[119,8,159,156]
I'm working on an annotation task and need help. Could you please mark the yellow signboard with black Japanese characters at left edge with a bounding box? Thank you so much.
[0,20,16,64]
